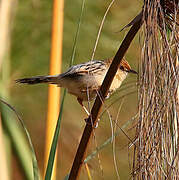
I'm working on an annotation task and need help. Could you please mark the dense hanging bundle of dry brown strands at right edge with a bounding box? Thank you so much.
[133,0,179,180]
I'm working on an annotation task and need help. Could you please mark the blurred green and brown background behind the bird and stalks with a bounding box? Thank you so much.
[9,0,142,179]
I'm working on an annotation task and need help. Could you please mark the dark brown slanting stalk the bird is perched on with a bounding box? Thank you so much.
[69,10,143,180]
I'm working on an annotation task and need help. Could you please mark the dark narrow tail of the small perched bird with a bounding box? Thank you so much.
[16,76,58,84]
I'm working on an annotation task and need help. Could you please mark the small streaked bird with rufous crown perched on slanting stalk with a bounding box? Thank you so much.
[16,58,137,114]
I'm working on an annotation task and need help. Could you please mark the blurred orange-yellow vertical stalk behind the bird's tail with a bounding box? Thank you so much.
[44,0,64,180]
